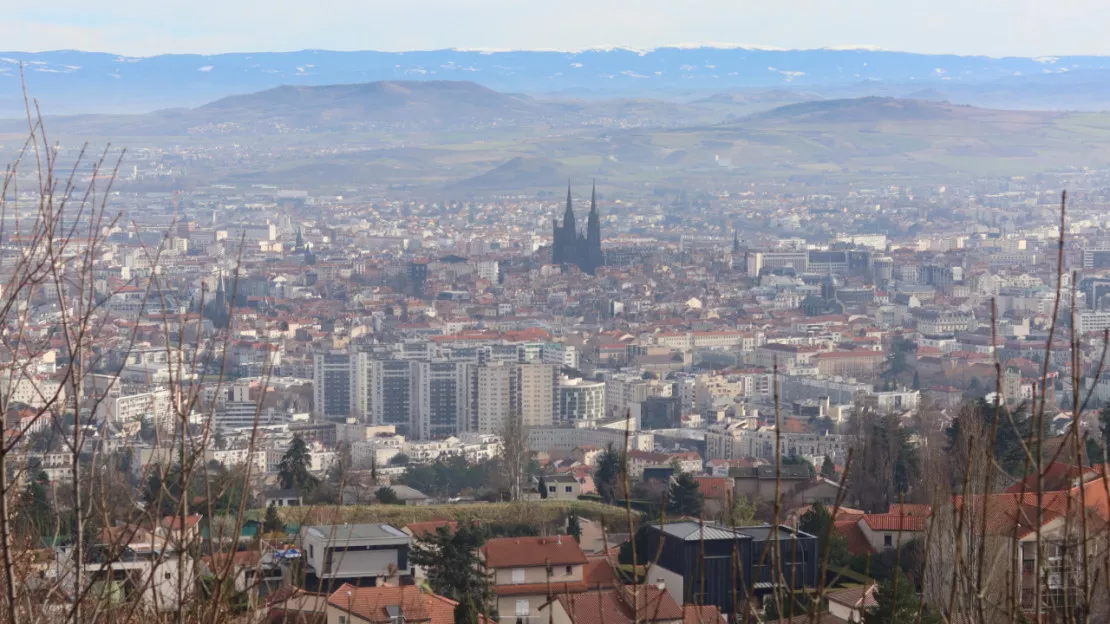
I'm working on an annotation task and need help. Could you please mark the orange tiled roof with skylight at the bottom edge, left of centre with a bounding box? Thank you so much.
[327,583,485,624]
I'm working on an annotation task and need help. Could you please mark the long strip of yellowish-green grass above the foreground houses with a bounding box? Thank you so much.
[269,501,636,530]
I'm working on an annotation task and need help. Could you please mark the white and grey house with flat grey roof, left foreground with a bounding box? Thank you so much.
[301,524,412,591]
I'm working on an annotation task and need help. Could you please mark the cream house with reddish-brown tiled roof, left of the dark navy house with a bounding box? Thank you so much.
[481,535,589,624]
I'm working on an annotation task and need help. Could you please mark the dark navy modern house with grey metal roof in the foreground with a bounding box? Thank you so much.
[636,521,819,615]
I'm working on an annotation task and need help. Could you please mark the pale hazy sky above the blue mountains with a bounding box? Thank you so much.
[8,0,1110,56]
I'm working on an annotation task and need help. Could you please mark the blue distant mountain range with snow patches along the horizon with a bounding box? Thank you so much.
[0,48,1110,117]
